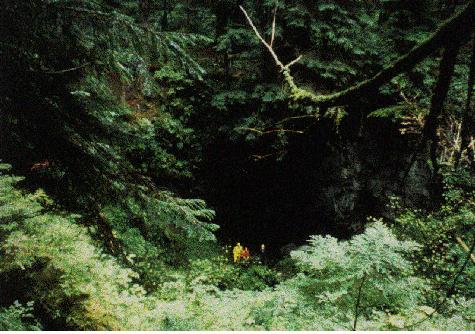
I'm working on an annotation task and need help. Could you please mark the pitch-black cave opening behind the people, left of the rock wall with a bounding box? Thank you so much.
[201,122,353,259]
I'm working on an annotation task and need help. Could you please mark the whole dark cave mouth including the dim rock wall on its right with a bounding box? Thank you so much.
[204,112,431,252]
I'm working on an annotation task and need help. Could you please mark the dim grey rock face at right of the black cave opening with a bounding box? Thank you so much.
[316,125,431,235]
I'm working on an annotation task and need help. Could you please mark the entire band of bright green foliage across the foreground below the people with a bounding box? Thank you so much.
[0,165,475,330]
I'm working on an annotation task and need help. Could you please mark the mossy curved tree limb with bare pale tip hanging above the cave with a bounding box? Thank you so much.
[239,0,475,107]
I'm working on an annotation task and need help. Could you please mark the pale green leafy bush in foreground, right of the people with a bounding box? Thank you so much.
[247,223,423,330]
